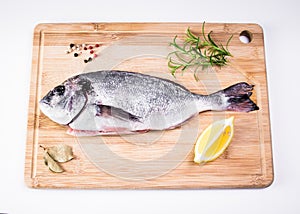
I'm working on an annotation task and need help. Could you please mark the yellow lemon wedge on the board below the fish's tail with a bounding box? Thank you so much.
[194,117,234,164]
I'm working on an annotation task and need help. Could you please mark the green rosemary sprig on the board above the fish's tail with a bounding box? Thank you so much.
[168,22,233,81]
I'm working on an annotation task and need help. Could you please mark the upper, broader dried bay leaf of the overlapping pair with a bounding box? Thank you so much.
[47,144,74,163]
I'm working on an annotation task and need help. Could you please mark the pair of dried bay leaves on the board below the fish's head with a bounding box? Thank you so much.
[40,144,74,173]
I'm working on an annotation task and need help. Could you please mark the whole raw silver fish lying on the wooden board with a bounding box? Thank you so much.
[40,70,258,135]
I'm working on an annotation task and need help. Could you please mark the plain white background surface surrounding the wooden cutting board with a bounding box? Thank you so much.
[0,0,300,214]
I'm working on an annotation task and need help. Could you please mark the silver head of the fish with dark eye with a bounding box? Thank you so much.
[39,77,87,125]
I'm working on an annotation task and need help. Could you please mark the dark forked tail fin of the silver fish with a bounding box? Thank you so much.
[221,82,259,112]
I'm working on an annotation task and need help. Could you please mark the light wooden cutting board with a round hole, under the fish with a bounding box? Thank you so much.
[25,23,273,189]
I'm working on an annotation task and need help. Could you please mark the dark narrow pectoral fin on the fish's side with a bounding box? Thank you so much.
[96,104,140,122]
